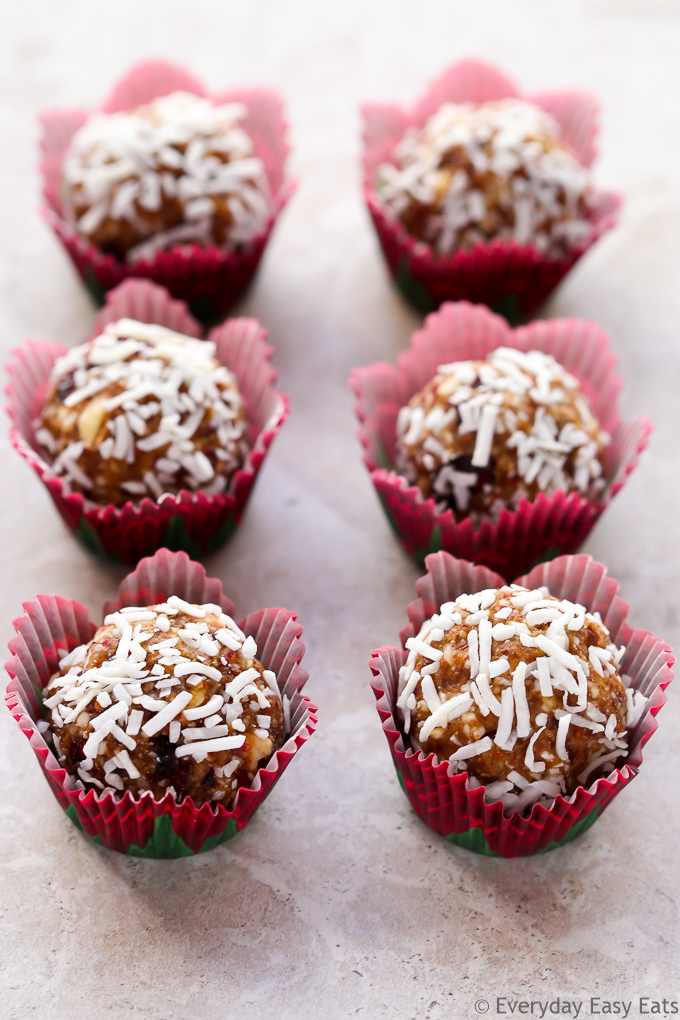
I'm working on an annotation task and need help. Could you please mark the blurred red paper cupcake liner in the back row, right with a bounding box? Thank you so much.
[362,60,622,321]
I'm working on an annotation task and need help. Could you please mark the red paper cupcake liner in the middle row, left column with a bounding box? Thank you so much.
[5,279,289,563]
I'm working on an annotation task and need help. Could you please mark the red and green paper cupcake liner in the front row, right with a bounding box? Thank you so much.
[370,553,675,857]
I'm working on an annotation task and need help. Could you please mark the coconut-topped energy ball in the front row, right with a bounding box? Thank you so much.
[397,584,645,811]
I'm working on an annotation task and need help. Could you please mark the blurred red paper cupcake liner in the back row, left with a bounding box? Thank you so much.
[41,61,295,320]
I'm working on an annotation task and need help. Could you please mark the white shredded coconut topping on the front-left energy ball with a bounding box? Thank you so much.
[43,597,283,799]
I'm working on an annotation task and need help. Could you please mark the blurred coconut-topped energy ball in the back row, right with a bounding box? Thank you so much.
[377,99,592,257]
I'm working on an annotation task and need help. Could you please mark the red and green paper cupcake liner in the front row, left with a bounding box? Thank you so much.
[5,549,317,857]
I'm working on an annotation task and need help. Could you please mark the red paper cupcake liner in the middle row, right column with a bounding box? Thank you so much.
[351,301,651,577]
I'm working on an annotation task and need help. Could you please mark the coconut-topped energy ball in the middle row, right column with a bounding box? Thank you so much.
[396,347,609,522]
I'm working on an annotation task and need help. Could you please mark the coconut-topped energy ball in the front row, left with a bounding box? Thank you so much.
[44,596,284,807]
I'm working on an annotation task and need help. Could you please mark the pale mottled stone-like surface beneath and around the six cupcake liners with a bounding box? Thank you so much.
[0,0,680,1020]
